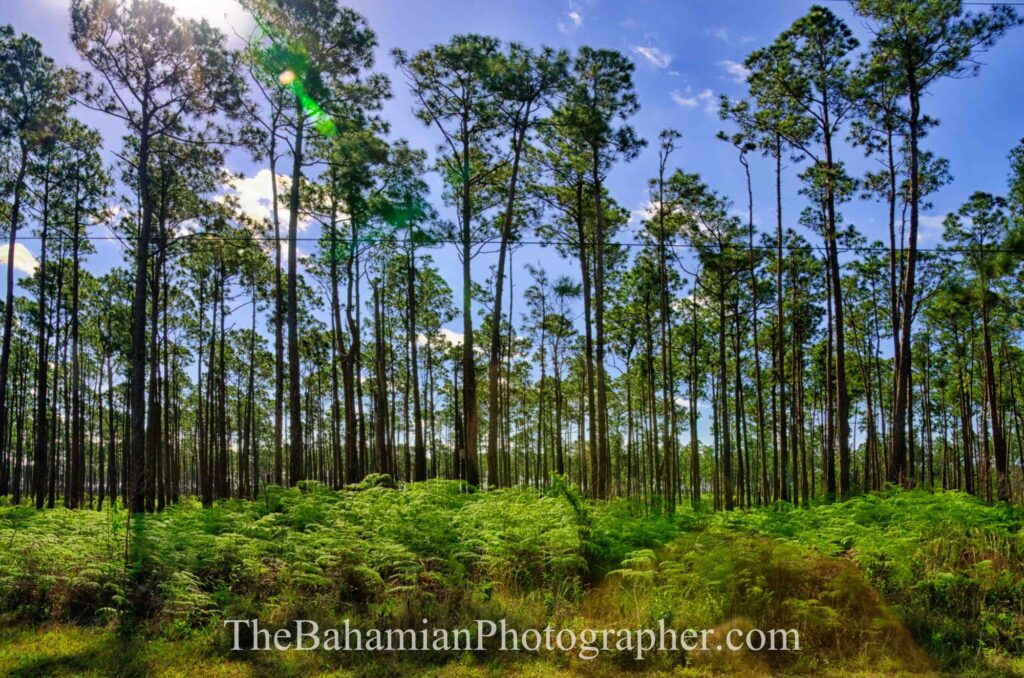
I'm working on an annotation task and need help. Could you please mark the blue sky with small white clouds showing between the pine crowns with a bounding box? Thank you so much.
[0,0,1024,438]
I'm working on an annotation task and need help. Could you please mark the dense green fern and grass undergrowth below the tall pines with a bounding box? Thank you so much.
[0,477,1024,675]
